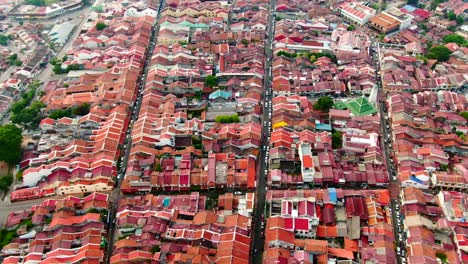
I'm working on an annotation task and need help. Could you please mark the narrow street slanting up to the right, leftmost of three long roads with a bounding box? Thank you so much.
[106,0,164,263]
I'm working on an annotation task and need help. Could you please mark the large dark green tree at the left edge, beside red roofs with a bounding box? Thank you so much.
[0,124,23,165]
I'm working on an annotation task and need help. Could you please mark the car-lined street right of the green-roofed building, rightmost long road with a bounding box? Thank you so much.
[371,39,406,264]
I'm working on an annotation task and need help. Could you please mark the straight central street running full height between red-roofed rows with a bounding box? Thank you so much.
[250,0,276,263]
